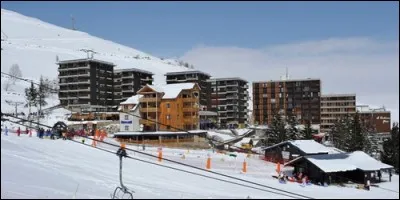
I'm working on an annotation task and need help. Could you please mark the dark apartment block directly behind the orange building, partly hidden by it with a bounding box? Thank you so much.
[165,70,211,110]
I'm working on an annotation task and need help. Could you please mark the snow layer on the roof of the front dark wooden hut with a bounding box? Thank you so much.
[305,151,393,173]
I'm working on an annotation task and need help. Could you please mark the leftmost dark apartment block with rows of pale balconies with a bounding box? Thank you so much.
[57,58,115,111]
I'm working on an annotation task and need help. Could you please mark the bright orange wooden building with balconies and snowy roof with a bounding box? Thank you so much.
[137,83,200,131]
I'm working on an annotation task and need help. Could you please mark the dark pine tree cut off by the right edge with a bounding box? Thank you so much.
[381,123,399,173]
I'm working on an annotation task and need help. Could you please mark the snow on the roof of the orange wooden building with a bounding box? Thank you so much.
[147,83,196,99]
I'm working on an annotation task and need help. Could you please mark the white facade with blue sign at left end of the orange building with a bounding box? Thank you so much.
[119,95,142,132]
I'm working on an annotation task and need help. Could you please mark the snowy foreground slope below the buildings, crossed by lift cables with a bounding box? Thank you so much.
[1,133,399,199]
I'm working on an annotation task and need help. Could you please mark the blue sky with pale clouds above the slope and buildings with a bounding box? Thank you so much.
[1,2,399,121]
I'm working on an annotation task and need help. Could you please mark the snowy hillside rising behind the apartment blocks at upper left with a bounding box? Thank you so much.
[1,9,189,84]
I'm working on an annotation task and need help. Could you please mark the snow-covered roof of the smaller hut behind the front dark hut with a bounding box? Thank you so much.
[264,140,340,154]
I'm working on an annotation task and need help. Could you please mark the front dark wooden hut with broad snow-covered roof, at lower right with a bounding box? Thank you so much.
[284,151,393,185]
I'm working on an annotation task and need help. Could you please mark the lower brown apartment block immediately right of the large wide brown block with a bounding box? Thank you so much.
[320,94,356,132]
